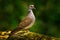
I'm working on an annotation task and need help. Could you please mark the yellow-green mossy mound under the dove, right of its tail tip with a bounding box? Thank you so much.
[8,31,59,40]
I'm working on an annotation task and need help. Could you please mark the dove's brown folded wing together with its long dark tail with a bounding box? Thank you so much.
[9,17,32,36]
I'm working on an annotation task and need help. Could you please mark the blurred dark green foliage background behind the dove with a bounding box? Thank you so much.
[0,0,60,37]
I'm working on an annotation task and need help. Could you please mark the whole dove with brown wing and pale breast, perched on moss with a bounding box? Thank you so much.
[9,5,35,36]
